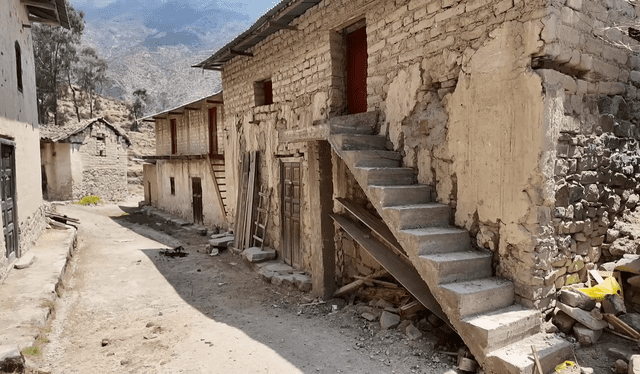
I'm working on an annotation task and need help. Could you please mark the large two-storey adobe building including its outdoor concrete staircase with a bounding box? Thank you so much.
[196,0,640,373]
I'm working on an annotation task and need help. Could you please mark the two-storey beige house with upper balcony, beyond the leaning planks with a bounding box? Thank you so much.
[143,92,228,228]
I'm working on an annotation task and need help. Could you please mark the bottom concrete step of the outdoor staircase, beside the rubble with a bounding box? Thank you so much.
[485,333,573,374]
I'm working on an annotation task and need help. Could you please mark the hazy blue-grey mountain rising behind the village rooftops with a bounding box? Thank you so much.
[72,0,251,114]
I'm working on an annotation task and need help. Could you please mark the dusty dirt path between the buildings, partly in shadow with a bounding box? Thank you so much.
[31,205,455,374]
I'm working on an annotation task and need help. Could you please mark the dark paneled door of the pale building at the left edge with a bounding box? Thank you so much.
[0,141,18,261]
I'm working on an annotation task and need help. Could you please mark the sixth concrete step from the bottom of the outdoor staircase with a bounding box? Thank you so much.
[382,203,451,230]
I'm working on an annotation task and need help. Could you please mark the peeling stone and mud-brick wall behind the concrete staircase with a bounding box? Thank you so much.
[218,0,640,309]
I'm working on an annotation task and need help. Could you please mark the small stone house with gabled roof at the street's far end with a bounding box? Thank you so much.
[40,118,131,201]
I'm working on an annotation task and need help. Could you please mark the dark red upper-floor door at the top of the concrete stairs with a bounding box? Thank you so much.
[346,27,368,114]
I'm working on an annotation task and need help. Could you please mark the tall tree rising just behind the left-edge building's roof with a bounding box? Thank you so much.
[32,0,84,124]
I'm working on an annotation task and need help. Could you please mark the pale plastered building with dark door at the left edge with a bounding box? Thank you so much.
[0,0,69,281]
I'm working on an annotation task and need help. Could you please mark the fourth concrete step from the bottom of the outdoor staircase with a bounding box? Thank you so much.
[420,250,493,284]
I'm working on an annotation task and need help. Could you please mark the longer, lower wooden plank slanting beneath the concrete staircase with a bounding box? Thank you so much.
[329,214,449,323]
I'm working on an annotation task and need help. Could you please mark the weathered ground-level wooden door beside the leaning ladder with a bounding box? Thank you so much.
[281,161,302,268]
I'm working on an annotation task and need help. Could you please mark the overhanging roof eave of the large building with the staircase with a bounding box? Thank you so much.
[193,0,321,70]
